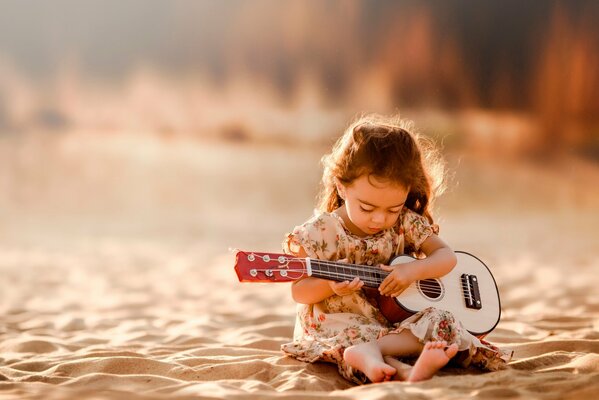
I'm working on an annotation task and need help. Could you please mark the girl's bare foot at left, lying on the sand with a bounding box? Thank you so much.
[343,342,397,382]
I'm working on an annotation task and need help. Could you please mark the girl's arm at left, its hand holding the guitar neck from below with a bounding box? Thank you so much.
[291,247,364,304]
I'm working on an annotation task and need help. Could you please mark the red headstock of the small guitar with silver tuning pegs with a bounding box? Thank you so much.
[235,250,307,282]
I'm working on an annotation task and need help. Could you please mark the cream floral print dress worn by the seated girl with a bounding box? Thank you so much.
[281,208,510,384]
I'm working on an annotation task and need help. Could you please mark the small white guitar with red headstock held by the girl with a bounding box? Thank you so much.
[235,250,501,338]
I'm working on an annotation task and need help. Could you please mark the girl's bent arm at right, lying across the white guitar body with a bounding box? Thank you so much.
[379,235,457,296]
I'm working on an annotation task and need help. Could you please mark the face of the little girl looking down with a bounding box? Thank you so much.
[337,175,409,236]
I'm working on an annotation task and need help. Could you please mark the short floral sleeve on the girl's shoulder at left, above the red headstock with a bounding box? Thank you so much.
[283,213,342,260]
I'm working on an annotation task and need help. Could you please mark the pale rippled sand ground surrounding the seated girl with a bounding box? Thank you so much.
[0,135,599,400]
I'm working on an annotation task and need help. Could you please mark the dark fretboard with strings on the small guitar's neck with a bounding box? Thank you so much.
[310,258,389,288]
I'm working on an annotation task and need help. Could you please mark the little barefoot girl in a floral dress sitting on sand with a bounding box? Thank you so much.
[282,115,509,384]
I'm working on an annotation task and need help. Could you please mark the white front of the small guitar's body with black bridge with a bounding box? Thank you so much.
[391,251,501,336]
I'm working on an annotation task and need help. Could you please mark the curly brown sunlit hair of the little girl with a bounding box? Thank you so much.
[318,114,445,224]
